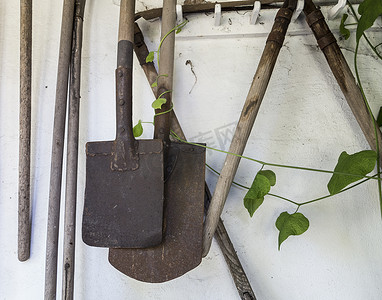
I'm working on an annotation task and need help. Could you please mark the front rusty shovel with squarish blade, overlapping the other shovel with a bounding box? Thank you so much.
[82,0,164,248]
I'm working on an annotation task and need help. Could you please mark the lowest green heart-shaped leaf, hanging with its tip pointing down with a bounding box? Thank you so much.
[276,211,309,250]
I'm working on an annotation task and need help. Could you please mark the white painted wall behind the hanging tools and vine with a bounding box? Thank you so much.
[0,0,382,300]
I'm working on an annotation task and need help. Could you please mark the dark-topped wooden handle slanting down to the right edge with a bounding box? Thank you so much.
[304,0,382,161]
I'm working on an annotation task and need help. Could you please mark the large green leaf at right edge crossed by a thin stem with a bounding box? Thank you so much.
[328,150,377,195]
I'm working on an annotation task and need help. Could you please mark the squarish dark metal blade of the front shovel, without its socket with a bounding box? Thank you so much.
[82,140,164,248]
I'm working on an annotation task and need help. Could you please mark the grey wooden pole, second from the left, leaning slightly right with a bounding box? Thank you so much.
[45,0,76,300]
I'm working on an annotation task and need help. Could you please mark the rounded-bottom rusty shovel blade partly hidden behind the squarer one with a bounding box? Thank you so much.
[109,143,205,283]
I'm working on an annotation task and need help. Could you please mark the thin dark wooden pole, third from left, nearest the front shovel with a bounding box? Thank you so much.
[62,0,86,300]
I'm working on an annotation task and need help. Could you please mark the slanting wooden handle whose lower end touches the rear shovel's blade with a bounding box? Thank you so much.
[203,0,297,256]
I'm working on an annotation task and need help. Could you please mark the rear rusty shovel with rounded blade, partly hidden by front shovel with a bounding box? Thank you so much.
[109,0,205,283]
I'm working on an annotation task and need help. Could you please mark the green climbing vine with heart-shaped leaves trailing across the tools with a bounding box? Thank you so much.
[134,0,382,249]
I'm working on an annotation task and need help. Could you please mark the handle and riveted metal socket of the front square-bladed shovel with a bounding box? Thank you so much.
[111,0,139,171]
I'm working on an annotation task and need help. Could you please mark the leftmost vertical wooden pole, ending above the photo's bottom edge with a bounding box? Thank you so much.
[18,0,32,261]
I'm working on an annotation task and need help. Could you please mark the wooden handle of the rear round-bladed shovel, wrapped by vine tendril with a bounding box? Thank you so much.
[154,0,176,142]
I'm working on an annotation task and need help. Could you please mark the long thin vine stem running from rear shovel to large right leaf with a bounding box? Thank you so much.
[171,131,380,180]
